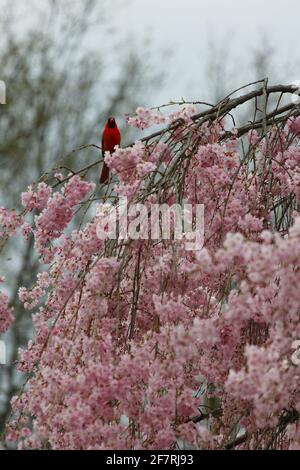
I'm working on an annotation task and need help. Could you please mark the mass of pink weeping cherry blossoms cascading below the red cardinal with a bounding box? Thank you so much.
[6,108,300,449]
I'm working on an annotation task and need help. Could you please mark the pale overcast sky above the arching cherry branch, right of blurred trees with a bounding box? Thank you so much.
[115,0,300,104]
